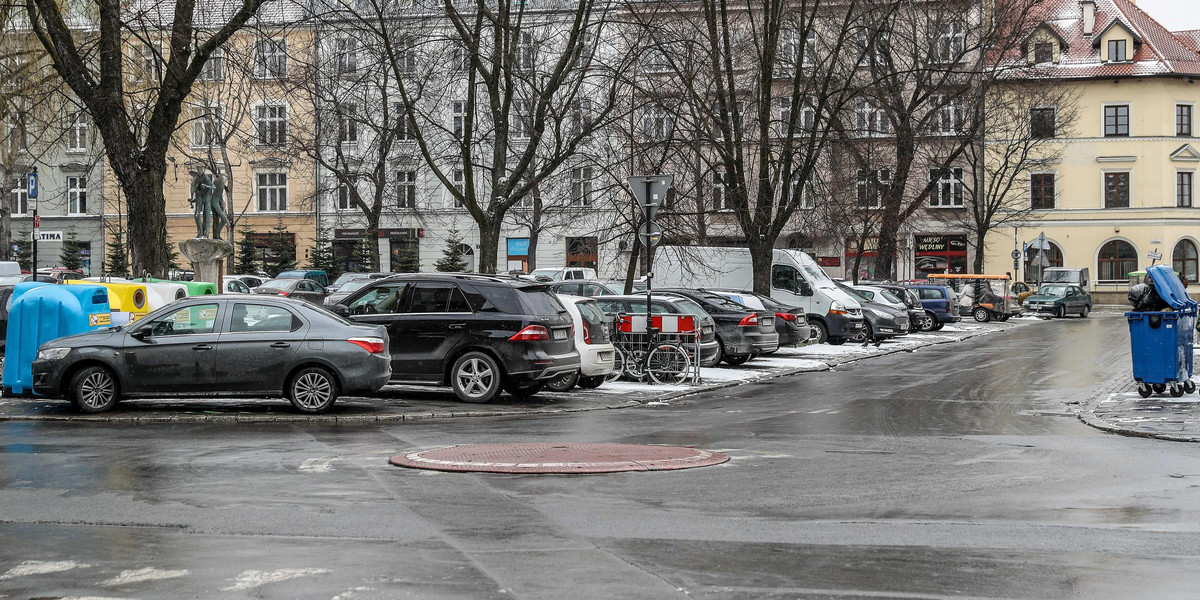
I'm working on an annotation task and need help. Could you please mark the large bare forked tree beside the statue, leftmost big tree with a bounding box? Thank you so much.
[25,0,272,275]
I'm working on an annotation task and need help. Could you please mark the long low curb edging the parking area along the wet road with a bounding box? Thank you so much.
[0,324,1024,425]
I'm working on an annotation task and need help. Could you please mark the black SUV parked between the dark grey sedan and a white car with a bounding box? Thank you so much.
[331,274,580,402]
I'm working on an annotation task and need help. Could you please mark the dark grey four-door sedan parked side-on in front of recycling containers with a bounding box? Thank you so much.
[32,295,391,413]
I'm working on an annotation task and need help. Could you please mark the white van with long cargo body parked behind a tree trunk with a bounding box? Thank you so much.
[654,246,863,344]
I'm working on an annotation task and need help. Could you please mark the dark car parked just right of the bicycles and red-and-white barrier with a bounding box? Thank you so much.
[654,288,779,366]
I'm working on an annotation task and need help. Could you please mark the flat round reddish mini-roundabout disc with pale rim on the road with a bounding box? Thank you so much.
[389,444,730,473]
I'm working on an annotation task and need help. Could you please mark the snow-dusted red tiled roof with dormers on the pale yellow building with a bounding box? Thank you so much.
[1009,0,1200,79]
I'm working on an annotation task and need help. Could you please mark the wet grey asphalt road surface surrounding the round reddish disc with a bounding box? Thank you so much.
[0,316,1200,600]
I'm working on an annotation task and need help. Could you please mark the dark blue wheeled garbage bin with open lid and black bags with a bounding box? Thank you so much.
[1126,265,1198,397]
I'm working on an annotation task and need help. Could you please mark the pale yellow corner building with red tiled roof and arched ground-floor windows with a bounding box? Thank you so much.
[986,0,1200,302]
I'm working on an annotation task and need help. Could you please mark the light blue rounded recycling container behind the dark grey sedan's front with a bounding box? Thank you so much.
[0,283,112,395]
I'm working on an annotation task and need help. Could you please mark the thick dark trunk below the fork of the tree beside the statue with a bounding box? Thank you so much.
[123,164,170,278]
